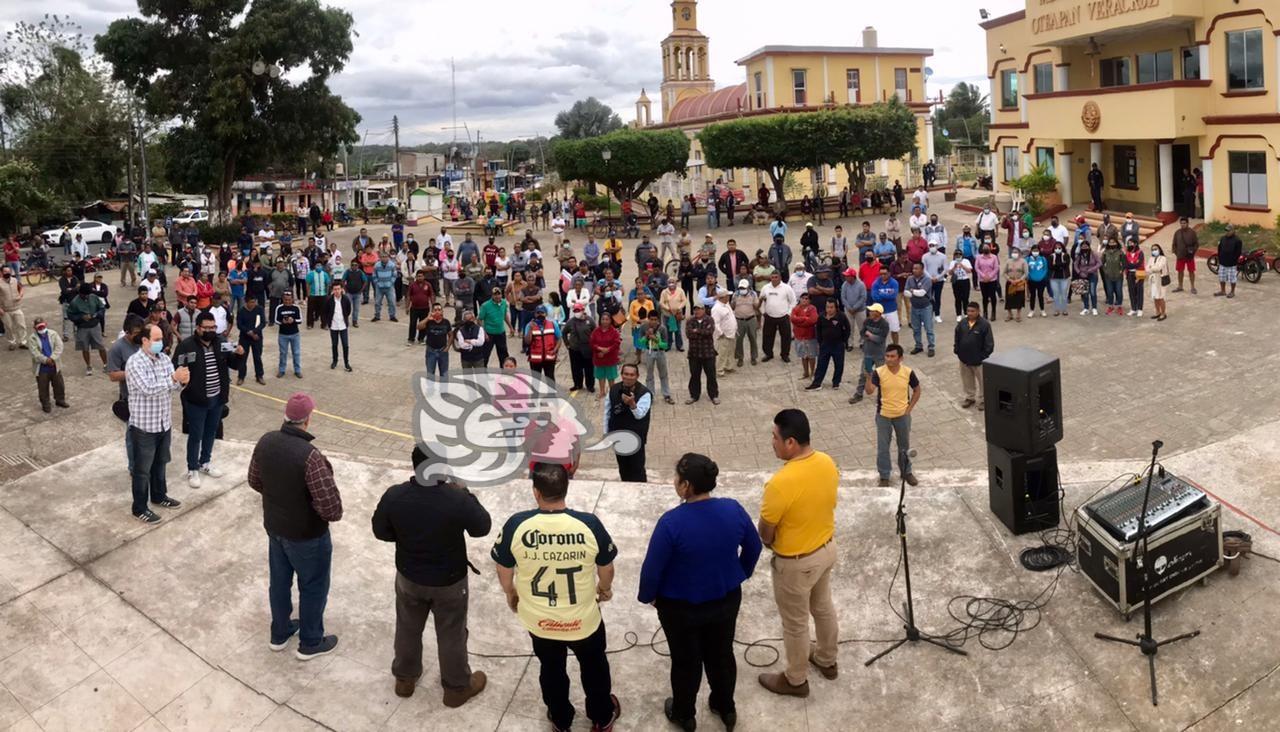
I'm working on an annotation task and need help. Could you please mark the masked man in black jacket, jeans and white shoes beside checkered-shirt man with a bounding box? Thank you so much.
[173,312,244,488]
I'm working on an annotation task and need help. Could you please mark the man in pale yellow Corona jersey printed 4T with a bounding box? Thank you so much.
[492,463,622,732]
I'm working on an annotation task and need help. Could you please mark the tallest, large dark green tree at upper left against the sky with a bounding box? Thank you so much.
[95,0,360,216]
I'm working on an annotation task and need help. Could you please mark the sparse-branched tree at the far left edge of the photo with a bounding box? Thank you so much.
[0,15,128,207]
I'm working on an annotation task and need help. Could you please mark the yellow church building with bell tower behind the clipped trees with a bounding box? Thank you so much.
[634,0,933,201]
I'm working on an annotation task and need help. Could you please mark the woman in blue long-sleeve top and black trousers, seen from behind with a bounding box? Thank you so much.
[640,453,760,729]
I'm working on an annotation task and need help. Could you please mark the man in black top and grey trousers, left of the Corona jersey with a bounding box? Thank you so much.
[372,447,492,706]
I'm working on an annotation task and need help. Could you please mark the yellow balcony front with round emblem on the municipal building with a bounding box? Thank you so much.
[1023,79,1211,139]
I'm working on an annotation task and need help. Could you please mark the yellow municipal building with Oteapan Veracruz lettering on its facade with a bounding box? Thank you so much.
[982,0,1280,227]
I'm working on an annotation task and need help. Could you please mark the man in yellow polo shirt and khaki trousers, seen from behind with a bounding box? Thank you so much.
[759,410,840,696]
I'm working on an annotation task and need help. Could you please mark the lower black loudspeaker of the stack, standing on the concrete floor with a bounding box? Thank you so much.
[987,444,1059,534]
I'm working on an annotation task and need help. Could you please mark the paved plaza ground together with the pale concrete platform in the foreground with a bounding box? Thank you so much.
[0,195,1280,731]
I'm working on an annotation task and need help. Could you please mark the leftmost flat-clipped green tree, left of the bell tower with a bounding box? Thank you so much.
[552,129,689,200]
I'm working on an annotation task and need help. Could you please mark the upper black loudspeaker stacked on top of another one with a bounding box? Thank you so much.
[982,347,1062,454]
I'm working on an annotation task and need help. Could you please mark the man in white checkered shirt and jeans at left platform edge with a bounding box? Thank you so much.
[124,325,191,523]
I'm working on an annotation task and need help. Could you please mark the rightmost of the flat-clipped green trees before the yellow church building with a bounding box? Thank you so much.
[804,104,918,191]
